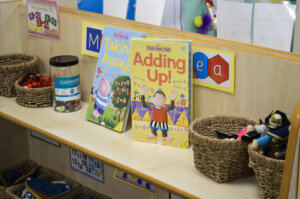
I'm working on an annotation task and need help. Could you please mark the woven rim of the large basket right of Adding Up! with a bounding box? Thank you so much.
[189,115,257,145]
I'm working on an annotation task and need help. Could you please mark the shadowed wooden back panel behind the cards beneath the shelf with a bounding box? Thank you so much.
[29,137,169,199]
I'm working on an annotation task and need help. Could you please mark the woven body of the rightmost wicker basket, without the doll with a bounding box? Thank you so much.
[248,146,284,199]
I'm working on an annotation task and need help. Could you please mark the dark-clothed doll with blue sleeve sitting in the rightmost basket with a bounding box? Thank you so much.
[251,110,290,159]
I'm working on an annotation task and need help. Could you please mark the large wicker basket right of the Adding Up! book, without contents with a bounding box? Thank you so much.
[190,116,255,183]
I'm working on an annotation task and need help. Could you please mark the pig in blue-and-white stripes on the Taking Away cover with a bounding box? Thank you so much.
[92,77,113,119]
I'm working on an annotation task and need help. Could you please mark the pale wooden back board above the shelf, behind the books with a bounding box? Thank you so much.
[13,7,300,119]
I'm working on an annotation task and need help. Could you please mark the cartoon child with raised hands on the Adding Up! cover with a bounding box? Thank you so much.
[140,85,179,142]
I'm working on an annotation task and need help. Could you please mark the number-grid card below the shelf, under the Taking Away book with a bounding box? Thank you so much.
[70,149,104,183]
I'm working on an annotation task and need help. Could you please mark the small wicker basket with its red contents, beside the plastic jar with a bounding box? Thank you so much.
[15,73,53,108]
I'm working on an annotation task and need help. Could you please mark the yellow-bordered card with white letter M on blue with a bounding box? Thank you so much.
[81,21,104,57]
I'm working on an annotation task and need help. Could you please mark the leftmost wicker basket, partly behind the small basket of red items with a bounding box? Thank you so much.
[0,54,37,97]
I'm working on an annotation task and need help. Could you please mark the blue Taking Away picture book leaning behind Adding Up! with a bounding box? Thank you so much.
[86,26,144,132]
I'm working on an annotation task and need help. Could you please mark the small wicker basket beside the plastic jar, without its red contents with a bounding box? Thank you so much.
[15,74,53,108]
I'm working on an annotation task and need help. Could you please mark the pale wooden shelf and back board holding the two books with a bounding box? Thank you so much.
[0,0,300,199]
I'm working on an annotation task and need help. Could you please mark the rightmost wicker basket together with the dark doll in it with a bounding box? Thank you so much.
[248,110,290,198]
